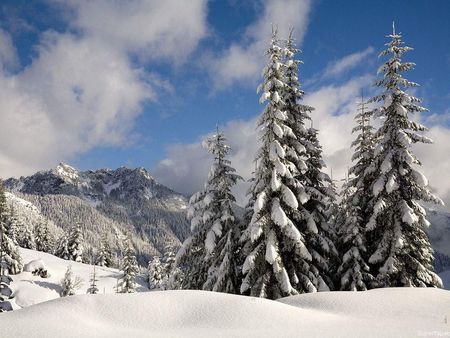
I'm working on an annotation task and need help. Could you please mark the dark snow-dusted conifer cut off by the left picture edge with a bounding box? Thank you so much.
[0,179,23,275]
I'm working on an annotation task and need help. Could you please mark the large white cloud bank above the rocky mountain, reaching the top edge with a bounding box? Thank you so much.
[0,0,207,177]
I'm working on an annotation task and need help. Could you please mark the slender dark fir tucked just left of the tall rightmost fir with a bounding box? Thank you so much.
[337,93,375,291]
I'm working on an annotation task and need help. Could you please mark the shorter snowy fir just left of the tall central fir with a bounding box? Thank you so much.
[175,130,241,293]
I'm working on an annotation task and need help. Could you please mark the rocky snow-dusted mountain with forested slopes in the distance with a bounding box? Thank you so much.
[5,163,189,265]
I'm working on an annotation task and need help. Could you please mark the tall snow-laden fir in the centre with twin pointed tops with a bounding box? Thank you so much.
[241,29,326,299]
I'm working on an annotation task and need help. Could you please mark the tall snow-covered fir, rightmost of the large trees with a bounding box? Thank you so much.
[366,27,442,287]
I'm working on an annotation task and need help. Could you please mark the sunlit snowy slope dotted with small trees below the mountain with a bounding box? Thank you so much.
[8,248,148,308]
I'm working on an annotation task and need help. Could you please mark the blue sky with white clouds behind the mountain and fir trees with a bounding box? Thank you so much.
[0,0,450,204]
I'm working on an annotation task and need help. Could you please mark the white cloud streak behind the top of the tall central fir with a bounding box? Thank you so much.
[208,0,311,89]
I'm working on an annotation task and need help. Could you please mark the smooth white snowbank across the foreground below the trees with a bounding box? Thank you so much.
[0,288,450,337]
